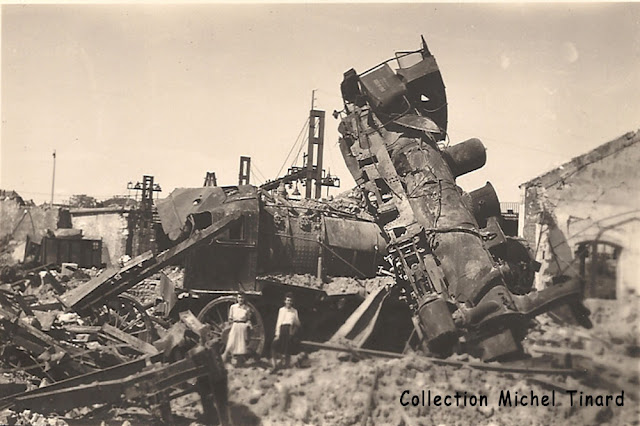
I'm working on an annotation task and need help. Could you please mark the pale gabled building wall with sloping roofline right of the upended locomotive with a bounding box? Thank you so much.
[521,132,640,298]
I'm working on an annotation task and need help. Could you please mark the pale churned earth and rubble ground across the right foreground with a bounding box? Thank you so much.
[202,292,640,426]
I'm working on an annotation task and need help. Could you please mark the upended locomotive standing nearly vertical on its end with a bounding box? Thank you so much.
[335,39,589,360]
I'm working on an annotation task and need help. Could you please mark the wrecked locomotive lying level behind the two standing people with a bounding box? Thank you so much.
[158,185,385,354]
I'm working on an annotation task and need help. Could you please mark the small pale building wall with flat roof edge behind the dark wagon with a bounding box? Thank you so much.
[71,208,130,265]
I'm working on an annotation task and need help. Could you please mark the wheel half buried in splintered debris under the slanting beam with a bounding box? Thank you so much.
[94,295,153,343]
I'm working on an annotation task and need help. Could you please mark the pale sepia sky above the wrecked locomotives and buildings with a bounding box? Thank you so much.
[0,3,640,202]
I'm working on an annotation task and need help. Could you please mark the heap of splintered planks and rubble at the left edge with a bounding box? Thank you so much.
[0,248,208,425]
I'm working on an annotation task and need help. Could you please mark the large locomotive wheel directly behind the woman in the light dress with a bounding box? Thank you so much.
[198,296,265,356]
